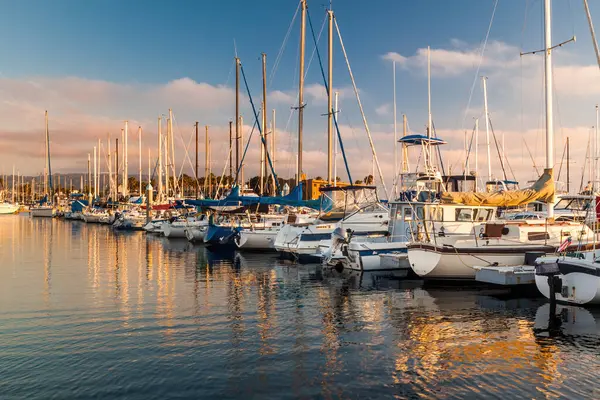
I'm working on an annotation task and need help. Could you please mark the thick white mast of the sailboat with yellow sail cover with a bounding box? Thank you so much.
[544,0,554,219]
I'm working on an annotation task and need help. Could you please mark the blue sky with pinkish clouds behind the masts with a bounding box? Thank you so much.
[0,0,600,191]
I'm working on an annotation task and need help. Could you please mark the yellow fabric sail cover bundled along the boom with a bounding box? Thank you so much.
[441,168,554,207]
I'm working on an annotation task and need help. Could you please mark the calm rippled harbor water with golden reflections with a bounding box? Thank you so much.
[0,215,600,399]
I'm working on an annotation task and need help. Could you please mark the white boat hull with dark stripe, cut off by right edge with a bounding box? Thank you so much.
[535,254,600,305]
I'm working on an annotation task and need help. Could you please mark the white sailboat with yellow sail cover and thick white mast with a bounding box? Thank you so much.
[408,0,600,280]
